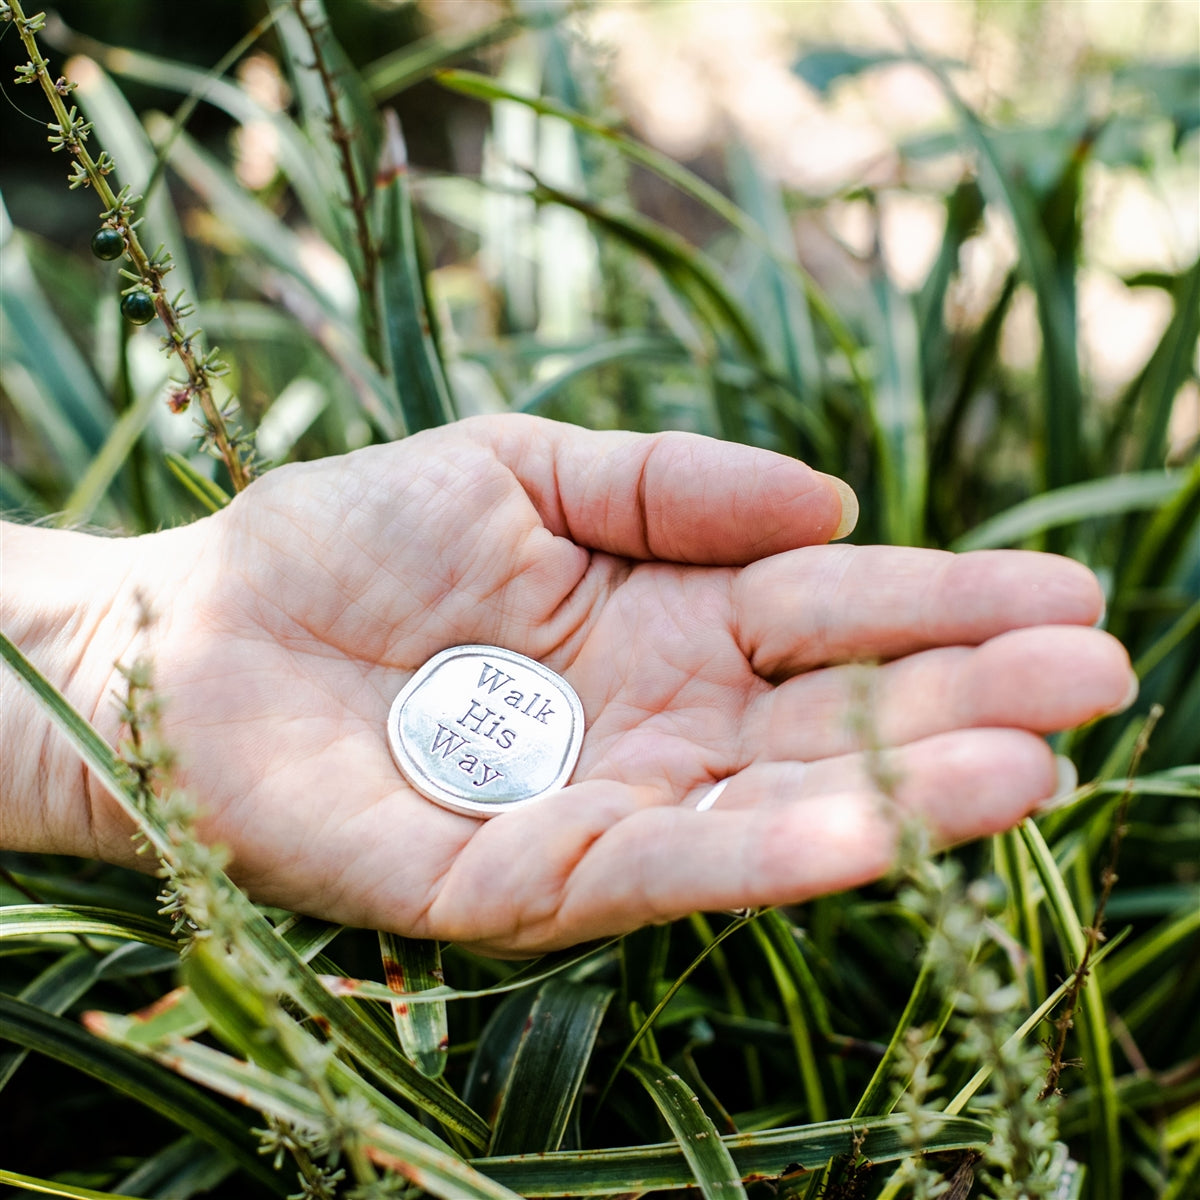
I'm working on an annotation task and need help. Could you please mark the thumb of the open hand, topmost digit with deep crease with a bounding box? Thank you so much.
[460,415,858,565]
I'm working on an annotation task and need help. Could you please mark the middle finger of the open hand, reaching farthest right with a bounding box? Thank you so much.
[743,625,1136,762]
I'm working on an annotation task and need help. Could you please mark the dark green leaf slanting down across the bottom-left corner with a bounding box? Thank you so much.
[0,995,284,1195]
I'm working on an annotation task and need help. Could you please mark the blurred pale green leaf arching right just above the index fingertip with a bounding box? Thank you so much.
[950,470,1187,552]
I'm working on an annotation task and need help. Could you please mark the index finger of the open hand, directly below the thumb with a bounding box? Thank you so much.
[733,546,1104,679]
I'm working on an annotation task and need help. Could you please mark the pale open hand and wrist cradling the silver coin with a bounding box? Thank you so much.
[0,416,1135,955]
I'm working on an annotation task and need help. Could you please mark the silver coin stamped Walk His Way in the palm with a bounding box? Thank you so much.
[388,646,583,816]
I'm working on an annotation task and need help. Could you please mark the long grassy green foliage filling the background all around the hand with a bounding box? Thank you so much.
[0,0,1200,1200]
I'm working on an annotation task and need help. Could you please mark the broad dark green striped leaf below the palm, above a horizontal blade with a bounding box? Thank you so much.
[488,978,613,1154]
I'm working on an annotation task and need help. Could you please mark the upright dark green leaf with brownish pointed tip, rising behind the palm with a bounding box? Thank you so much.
[376,109,454,433]
